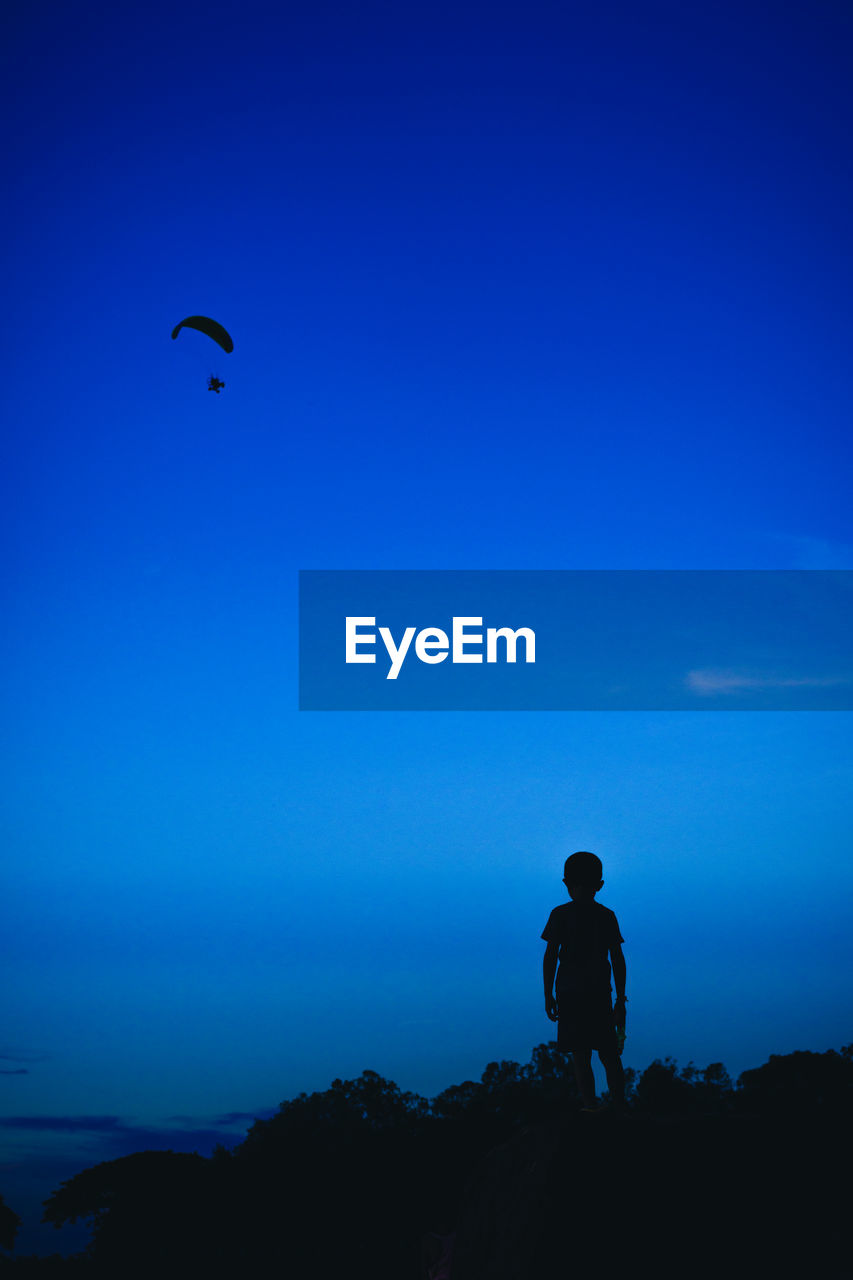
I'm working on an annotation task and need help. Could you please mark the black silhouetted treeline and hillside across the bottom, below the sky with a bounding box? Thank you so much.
[0,1043,853,1280]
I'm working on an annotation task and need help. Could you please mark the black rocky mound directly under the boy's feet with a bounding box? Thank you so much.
[452,1115,850,1280]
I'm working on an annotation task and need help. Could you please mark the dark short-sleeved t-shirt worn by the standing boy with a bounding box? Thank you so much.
[542,902,625,998]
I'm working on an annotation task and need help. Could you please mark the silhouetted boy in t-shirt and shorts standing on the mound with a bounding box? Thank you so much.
[542,850,625,1111]
